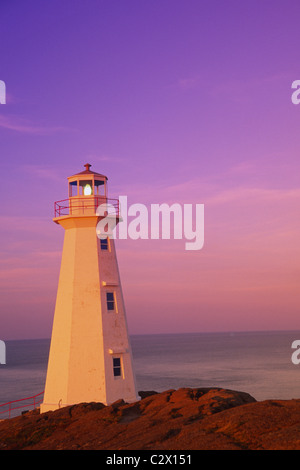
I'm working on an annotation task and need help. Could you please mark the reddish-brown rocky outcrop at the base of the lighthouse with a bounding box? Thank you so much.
[0,388,300,450]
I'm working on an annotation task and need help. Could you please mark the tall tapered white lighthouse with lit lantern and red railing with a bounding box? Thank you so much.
[41,164,139,413]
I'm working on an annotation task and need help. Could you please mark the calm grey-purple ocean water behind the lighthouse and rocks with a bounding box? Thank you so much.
[0,331,300,419]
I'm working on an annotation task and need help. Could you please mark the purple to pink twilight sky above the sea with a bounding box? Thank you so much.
[0,0,300,340]
